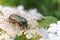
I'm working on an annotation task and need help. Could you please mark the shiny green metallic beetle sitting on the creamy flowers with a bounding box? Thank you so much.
[9,14,28,27]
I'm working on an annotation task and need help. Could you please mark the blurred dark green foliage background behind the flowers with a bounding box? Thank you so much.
[0,0,60,20]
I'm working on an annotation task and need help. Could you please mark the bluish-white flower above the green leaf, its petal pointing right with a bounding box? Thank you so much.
[29,9,43,20]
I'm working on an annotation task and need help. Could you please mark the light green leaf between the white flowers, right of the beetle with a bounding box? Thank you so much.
[38,16,58,29]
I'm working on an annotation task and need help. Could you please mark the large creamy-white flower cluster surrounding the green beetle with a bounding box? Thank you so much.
[0,5,45,40]
